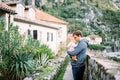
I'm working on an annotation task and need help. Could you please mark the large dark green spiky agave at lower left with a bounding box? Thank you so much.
[7,54,36,80]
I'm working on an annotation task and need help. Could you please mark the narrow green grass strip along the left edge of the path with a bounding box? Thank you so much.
[57,57,70,80]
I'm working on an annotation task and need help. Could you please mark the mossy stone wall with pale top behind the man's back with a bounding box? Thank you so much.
[85,51,120,80]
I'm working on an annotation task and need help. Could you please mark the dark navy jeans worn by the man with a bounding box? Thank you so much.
[72,65,85,80]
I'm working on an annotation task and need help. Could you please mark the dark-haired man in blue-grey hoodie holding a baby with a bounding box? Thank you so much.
[67,30,87,80]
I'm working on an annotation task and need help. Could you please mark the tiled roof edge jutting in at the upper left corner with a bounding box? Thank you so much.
[0,2,16,14]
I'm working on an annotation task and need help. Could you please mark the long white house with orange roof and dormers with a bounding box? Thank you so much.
[0,2,68,54]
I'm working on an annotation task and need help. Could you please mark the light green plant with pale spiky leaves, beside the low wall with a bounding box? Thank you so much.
[35,44,54,70]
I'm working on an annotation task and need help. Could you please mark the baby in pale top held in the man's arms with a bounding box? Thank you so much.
[67,37,77,61]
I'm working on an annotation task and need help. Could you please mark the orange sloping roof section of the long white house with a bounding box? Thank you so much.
[35,9,68,25]
